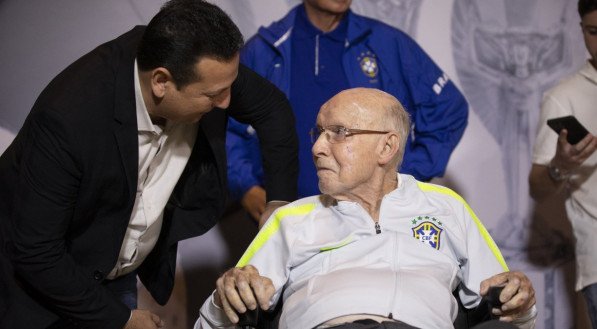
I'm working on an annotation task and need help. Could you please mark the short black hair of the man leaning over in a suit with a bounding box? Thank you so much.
[137,0,243,88]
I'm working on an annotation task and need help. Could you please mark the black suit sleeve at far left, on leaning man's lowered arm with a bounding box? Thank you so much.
[7,110,130,328]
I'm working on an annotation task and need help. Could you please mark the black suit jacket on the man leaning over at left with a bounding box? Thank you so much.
[0,27,298,328]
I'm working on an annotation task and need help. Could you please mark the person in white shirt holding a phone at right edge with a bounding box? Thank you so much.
[529,0,597,329]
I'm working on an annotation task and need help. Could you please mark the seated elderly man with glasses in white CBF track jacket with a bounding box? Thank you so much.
[195,88,536,328]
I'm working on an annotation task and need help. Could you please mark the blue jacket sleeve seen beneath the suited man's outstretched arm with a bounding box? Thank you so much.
[226,119,263,201]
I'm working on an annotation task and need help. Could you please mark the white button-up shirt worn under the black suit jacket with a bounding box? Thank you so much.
[108,60,197,279]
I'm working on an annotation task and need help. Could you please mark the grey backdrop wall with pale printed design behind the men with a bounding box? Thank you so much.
[0,0,587,329]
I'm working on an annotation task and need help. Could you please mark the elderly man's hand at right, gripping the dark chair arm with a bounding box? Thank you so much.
[480,272,535,322]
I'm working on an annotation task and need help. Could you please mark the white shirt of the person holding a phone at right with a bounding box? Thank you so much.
[533,62,597,291]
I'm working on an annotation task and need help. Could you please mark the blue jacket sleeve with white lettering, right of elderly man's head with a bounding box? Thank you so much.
[398,37,468,181]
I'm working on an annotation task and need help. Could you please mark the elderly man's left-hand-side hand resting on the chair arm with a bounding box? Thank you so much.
[214,265,275,323]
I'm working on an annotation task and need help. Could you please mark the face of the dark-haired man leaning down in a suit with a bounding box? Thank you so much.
[158,56,239,123]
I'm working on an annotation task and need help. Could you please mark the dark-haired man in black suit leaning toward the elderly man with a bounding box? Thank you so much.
[0,0,297,329]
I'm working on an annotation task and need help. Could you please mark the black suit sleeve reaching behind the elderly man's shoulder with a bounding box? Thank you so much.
[228,64,298,201]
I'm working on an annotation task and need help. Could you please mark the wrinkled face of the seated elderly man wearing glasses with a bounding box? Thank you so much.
[312,95,384,200]
